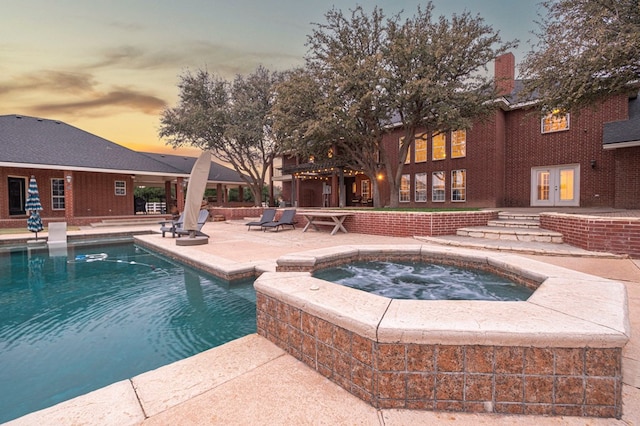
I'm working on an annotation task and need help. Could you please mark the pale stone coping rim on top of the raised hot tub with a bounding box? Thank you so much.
[255,245,630,348]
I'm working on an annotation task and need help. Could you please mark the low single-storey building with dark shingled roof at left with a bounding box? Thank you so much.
[0,115,250,228]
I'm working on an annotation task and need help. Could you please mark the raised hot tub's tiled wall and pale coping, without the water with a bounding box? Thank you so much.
[255,245,630,418]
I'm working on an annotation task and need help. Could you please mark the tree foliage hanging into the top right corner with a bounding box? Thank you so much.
[520,0,640,111]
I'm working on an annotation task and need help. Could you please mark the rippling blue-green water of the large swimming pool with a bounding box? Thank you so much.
[0,243,256,423]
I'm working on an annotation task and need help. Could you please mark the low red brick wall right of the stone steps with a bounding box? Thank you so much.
[540,213,640,258]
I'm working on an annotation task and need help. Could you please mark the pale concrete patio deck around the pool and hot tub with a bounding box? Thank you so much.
[0,221,640,425]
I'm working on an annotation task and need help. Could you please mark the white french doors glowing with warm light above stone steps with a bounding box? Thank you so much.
[531,164,580,207]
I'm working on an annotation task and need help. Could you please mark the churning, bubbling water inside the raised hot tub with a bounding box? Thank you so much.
[313,261,533,301]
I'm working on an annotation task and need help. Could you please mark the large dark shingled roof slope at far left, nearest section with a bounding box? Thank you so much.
[0,115,183,175]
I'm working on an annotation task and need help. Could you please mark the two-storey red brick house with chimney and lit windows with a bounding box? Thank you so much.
[277,54,640,209]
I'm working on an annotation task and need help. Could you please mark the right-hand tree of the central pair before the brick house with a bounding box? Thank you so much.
[384,3,517,207]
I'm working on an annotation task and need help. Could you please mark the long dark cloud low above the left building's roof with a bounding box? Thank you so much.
[30,87,167,116]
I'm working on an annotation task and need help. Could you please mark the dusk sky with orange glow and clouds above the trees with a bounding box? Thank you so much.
[0,0,540,155]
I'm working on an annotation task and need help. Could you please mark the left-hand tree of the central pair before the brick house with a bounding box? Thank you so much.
[274,7,396,205]
